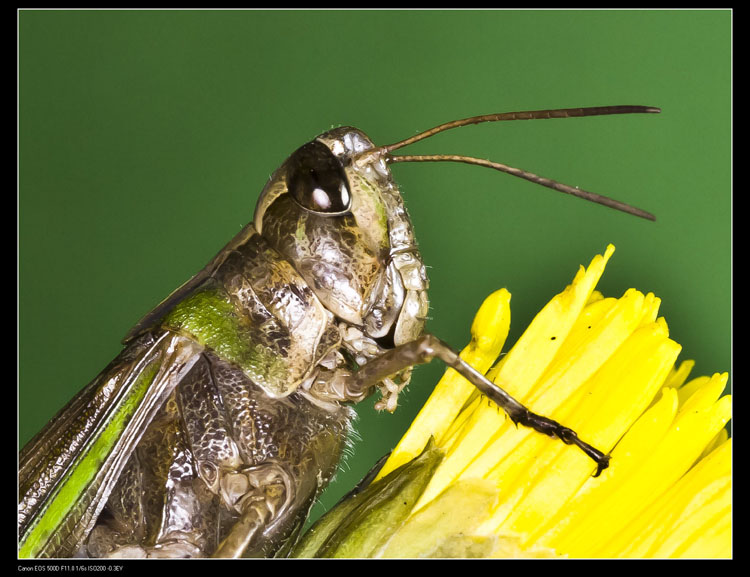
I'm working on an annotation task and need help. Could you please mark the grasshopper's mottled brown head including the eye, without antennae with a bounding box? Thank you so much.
[255,127,429,348]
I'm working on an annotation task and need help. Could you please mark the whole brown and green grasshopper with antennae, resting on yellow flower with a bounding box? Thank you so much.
[18,106,659,557]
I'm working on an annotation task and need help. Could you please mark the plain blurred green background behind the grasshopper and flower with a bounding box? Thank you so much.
[18,10,732,528]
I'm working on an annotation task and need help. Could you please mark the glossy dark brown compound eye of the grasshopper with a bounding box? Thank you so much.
[287,140,352,216]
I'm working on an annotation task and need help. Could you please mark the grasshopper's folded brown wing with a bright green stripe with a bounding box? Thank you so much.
[18,331,203,557]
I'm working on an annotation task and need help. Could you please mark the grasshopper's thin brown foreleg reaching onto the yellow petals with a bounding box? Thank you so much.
[350,334,609,476]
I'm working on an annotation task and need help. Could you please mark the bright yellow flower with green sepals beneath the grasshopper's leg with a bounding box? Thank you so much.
[295,245,731,558]
